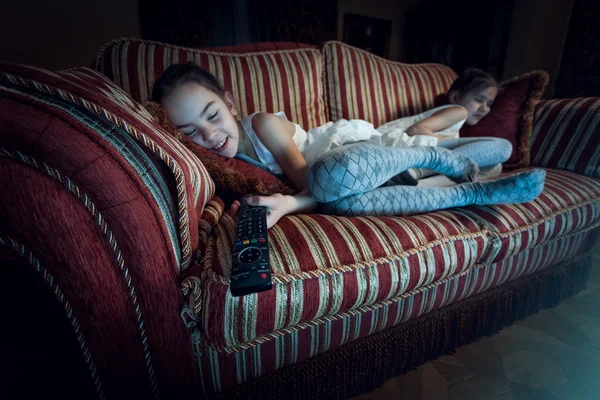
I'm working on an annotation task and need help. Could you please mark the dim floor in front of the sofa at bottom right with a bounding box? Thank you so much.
[353,246,600,400]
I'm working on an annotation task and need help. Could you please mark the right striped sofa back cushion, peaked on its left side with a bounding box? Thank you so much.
[323,41,456,127]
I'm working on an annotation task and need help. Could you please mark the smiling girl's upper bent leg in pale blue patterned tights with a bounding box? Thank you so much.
[306,142,478,203]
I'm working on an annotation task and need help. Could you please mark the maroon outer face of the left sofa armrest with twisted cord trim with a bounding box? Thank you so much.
[0,106,200,399]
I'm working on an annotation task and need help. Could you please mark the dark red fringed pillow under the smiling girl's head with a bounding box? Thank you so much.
[144,102,294,204]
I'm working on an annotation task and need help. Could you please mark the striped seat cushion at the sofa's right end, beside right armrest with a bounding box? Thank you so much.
[460,169,600,263]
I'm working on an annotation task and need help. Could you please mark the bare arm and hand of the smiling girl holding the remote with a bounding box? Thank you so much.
[241,113,317,228]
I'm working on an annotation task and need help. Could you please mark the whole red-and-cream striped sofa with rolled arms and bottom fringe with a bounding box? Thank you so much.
[0,38,600,399]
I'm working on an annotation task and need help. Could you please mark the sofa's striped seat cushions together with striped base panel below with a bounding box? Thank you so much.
[184,170,600,392]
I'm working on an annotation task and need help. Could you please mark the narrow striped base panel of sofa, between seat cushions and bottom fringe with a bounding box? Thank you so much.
[194,229,593,393]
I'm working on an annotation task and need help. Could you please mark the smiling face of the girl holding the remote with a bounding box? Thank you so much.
[161,82,240,158]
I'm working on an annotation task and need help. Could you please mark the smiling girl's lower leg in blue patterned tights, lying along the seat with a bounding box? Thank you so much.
[322,169,546,216]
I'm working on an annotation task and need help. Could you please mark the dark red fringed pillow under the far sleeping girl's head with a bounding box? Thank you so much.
[460,71,548,169]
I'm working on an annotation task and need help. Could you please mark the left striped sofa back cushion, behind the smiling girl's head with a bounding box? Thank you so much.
[94,39,327,129]
